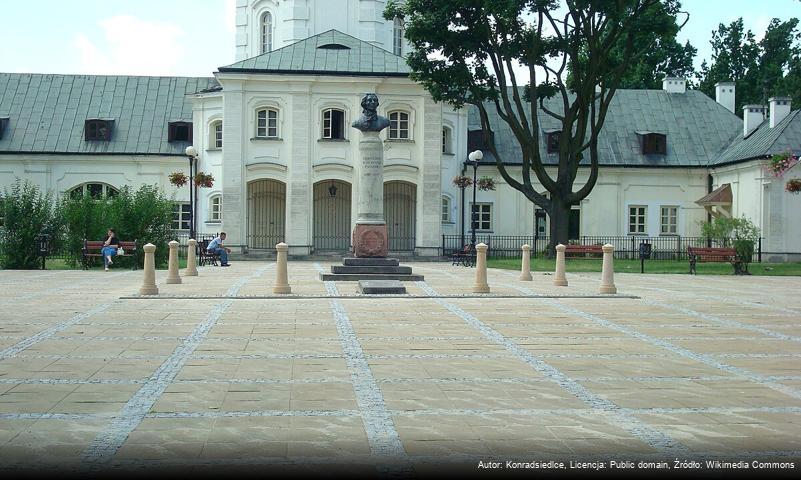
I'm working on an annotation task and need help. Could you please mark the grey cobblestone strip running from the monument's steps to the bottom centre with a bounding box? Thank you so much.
[314,263,411,473]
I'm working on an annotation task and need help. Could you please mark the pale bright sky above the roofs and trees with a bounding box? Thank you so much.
[0,0,801,76]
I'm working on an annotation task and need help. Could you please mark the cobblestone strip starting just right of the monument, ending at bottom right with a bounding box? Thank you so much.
[416,282,690,455]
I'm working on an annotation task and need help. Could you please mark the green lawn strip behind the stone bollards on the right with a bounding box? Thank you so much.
[487,258,801,275]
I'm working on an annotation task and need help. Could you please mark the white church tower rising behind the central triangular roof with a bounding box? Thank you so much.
[236,0,408,61]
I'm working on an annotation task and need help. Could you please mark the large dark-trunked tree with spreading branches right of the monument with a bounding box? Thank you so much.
[384,0,675,251]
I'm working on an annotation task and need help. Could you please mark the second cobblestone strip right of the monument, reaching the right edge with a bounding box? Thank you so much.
[507,285,801,399]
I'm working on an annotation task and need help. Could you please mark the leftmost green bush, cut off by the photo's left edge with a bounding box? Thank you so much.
[0,178,60,269]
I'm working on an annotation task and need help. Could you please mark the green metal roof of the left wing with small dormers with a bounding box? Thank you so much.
[0,73,217,155]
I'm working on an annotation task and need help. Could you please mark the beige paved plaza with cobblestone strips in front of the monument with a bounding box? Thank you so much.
[0,262,801,475]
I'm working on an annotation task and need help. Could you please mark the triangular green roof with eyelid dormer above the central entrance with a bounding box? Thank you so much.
[219,30,411,77]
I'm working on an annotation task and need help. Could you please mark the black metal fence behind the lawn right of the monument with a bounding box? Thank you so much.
[442,234,762,262]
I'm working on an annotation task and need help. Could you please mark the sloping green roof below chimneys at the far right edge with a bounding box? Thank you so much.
[710,110,801,166]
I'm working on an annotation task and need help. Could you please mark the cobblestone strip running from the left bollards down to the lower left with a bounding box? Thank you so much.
[81,264,273,465]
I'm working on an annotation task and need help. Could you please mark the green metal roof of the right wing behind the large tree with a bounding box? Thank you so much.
[468,90,743,167]
